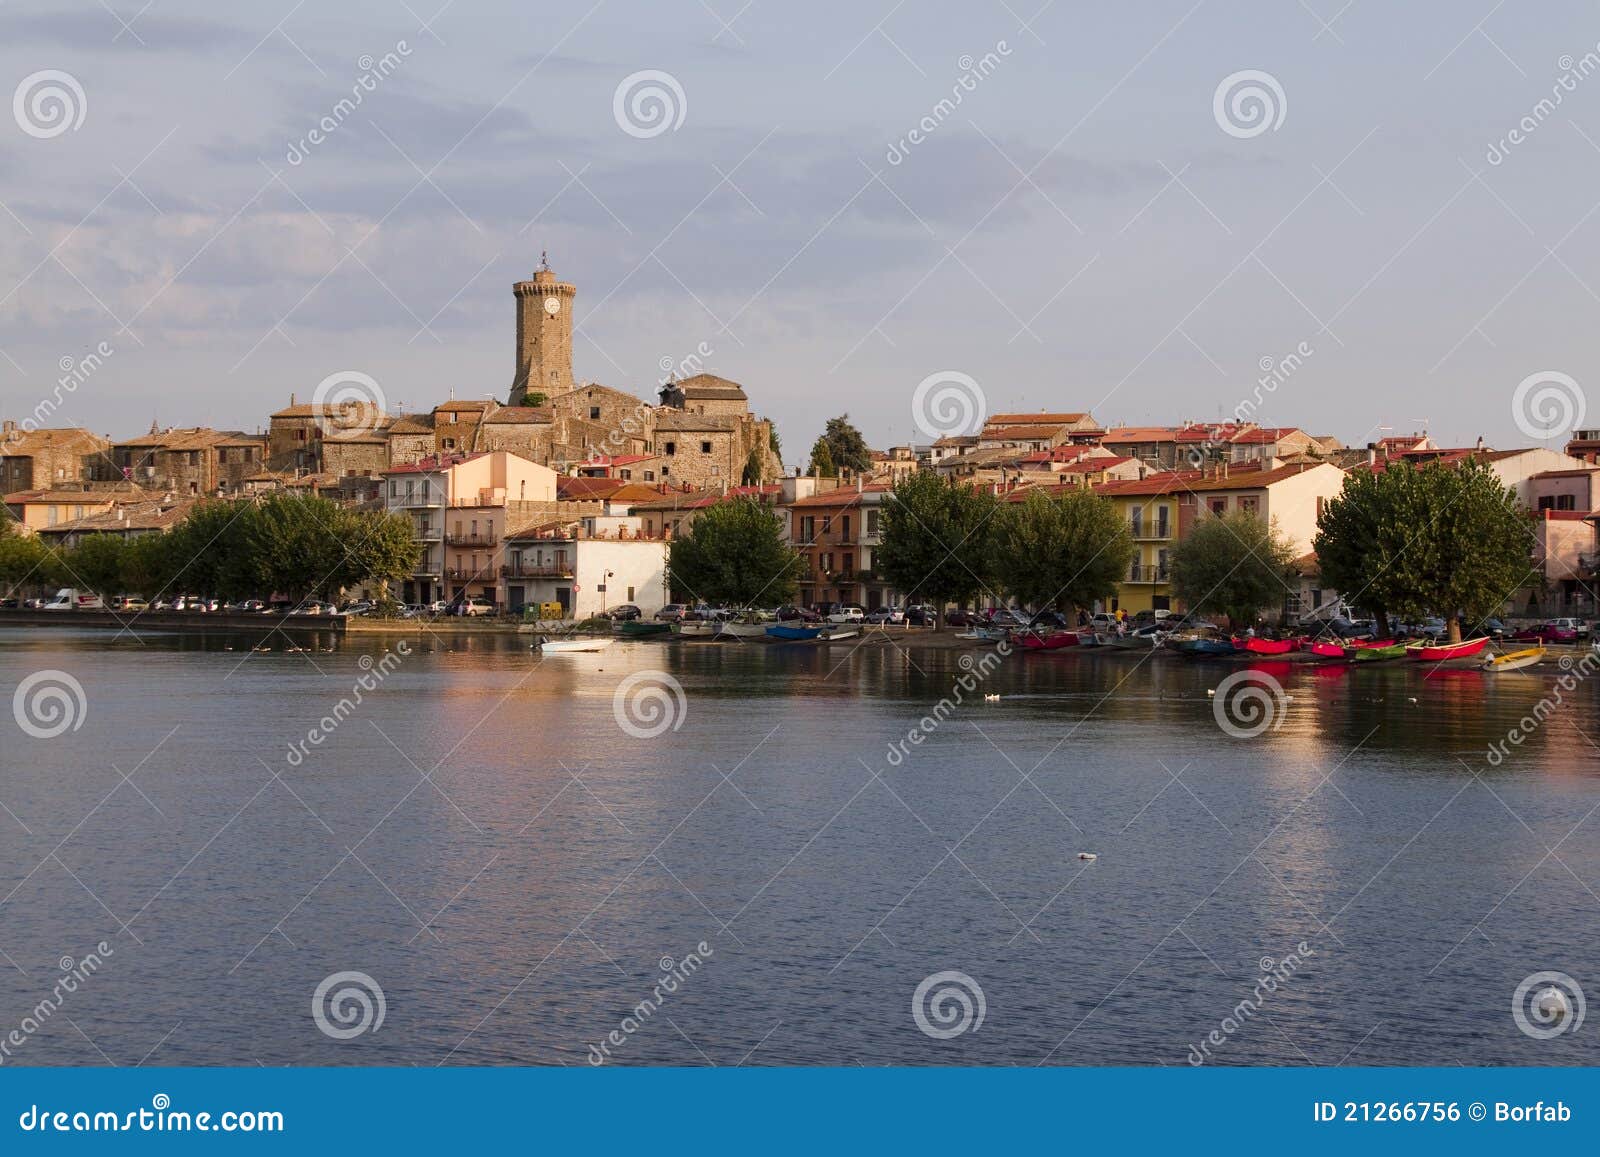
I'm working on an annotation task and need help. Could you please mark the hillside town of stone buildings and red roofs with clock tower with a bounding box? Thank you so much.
[0,262,1600,633]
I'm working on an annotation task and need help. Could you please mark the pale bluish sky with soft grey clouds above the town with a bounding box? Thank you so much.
[0,0,1600,462]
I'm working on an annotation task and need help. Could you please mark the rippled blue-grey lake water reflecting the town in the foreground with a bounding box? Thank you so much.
[0,629,1600,1066]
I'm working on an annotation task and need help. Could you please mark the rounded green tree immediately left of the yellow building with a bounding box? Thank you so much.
[994,488,1134,610]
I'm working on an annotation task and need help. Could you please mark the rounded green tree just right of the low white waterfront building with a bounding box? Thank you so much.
[667,498,802,607]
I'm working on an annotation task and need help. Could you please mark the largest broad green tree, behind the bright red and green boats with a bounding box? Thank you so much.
[1317,462,1538,642]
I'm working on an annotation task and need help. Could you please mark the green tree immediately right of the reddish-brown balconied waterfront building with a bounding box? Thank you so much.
[874,470,998,624]
